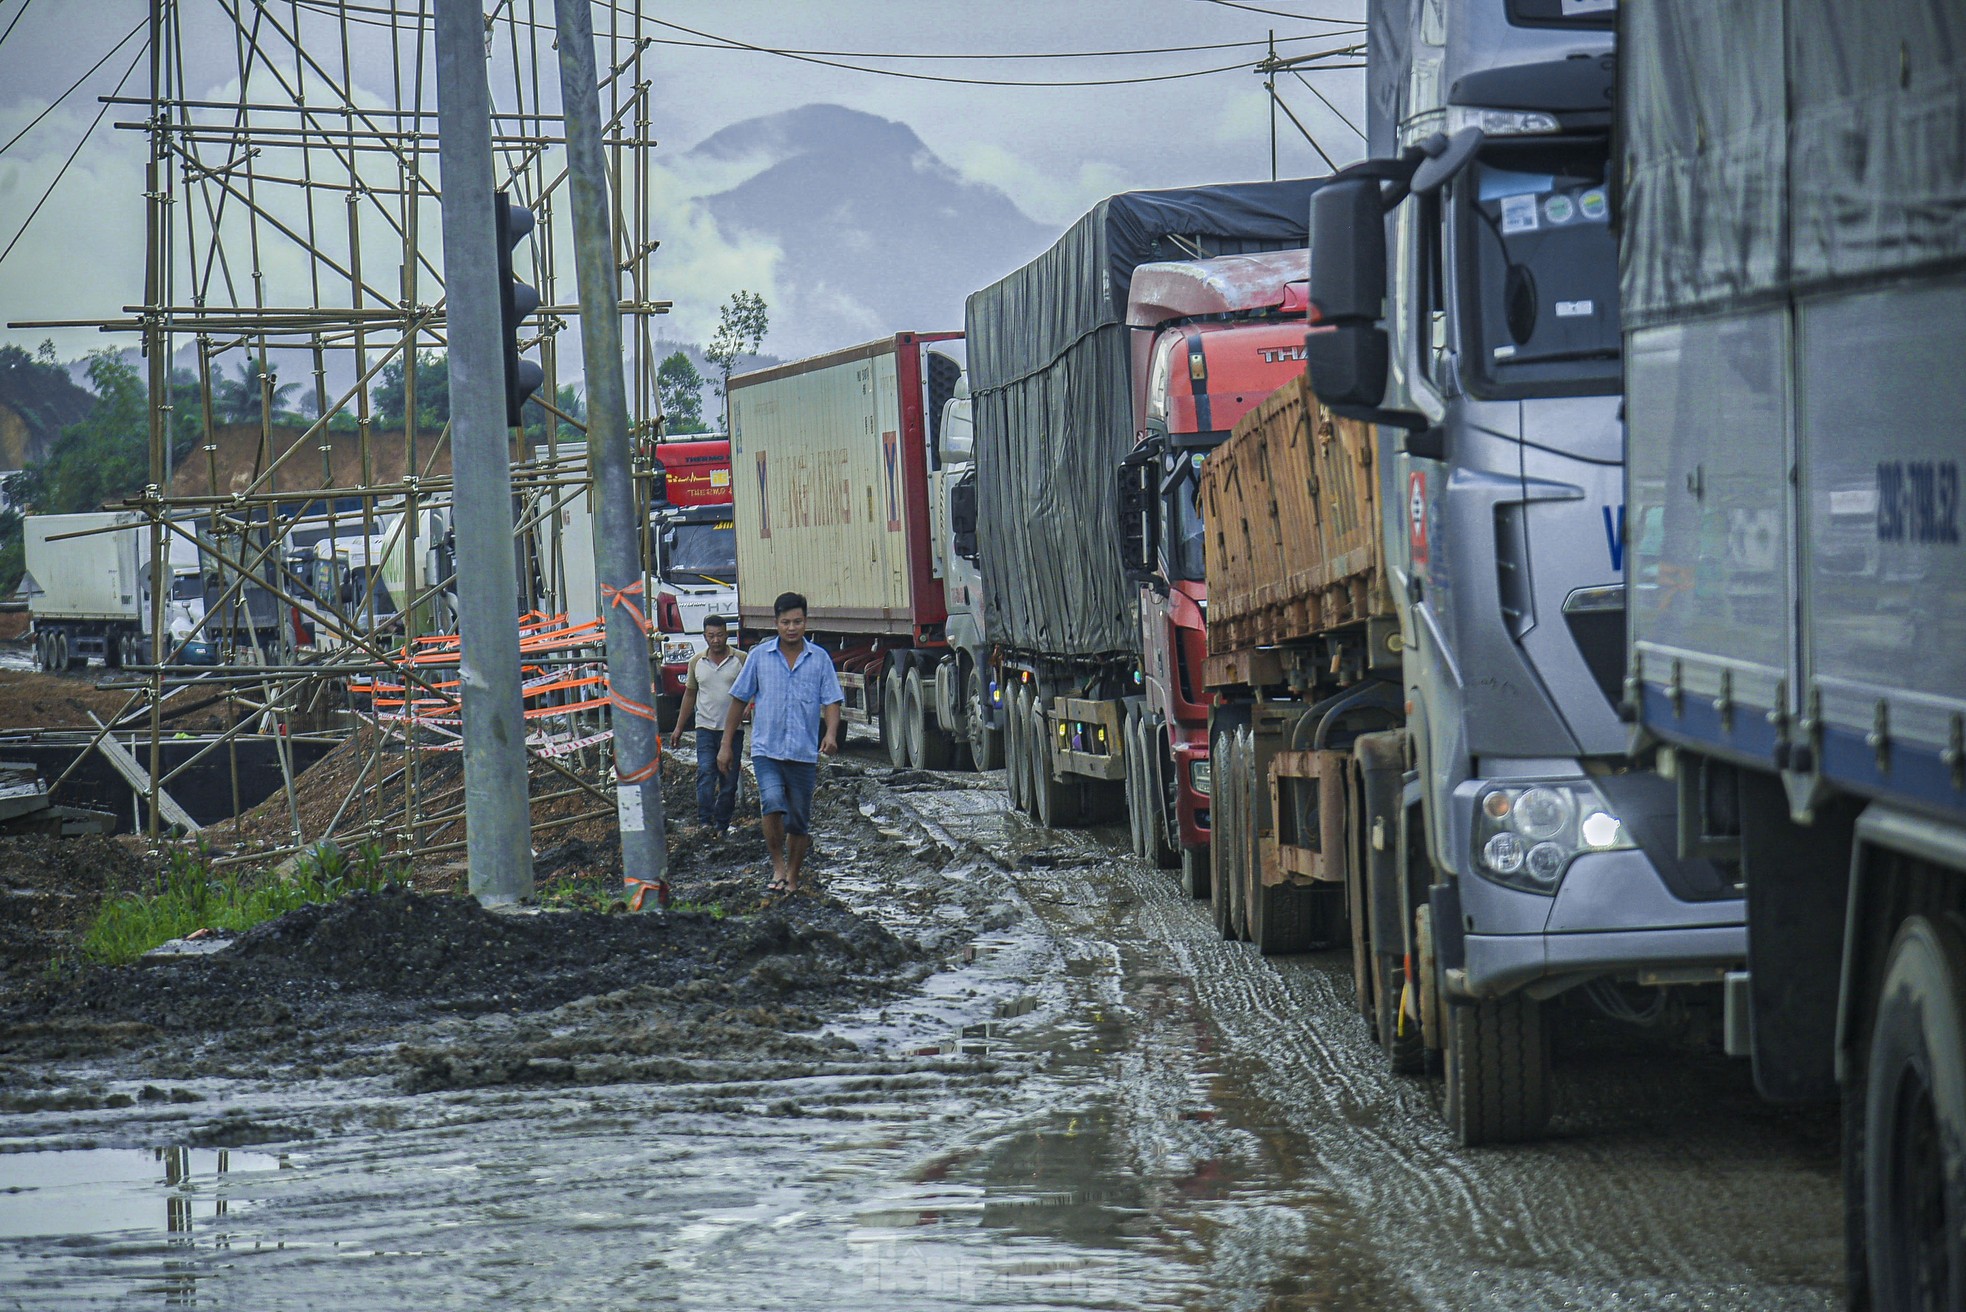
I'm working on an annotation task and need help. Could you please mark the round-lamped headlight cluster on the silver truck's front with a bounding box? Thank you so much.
[1475,779,1638,893]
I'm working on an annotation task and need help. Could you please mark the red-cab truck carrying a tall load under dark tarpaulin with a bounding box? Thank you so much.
[967,179,1317,861]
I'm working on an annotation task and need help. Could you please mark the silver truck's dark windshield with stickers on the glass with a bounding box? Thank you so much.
[1459,138,1622,397]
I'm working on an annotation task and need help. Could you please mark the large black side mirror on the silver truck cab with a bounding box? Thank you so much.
[1303,177,1390,407]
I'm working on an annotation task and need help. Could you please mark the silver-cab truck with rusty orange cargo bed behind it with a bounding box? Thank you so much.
[1179,0,1746,1145]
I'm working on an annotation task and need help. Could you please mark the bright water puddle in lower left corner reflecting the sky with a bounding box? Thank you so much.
[0,1149,291,1241]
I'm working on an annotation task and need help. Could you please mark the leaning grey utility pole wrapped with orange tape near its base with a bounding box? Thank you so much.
[554,0,668,905]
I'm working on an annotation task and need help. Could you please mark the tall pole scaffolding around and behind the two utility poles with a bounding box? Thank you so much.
[19,0,668,873]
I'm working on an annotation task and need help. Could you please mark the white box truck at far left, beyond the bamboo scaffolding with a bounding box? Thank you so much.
[22,511,206,671]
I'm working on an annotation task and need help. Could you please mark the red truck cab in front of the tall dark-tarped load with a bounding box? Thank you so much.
[1127,250,1309,869]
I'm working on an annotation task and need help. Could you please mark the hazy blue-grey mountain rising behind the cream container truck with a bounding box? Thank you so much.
[690,104,1056,356]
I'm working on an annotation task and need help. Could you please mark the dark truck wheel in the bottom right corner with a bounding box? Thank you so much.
[1864,917,1966,1308]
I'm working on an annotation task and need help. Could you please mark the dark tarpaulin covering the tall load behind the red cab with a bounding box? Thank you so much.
[965,179,1317,657]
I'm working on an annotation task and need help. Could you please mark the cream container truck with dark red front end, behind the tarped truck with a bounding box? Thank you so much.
[729,332,975,769]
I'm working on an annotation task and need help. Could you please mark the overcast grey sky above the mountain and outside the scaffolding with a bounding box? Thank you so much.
[0,0,1364,358]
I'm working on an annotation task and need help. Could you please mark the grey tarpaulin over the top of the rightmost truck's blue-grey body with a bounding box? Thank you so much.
[1618,0,1966,327]
